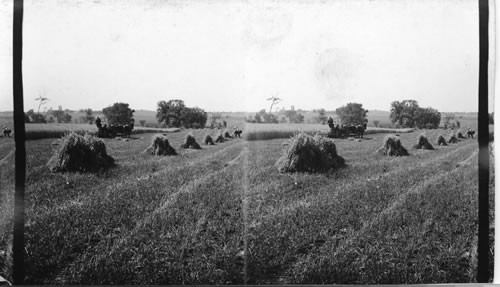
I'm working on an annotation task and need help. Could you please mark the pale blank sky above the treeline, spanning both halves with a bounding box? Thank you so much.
[0,0,492,112]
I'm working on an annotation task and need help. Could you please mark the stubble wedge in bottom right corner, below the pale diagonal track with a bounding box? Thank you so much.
[287,156,477,284]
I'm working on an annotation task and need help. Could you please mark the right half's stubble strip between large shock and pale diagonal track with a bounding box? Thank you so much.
[244,140,475,283]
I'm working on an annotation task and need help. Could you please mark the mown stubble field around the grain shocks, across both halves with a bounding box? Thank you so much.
[0,127,494,284]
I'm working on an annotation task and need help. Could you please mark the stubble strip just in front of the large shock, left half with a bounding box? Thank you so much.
[27,137,244,213]
